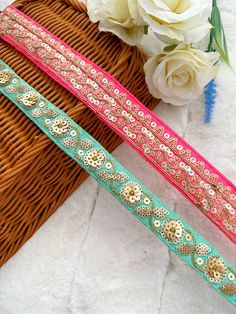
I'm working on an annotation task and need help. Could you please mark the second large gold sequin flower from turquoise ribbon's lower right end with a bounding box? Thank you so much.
[162,219,184,243]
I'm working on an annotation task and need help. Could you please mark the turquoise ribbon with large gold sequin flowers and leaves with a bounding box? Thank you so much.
[0,60,236,305]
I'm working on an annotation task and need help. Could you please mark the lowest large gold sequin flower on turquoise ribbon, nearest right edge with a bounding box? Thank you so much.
[204,256,227,282]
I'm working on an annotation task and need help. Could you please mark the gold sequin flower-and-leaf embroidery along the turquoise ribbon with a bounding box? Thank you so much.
[0,61,236,297]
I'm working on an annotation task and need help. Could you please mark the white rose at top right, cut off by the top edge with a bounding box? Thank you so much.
[138,0,211,43]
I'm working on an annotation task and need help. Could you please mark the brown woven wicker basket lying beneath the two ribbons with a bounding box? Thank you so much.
[0,0,159,265]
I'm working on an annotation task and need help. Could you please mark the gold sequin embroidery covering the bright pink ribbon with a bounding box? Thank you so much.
[1,9,236,238]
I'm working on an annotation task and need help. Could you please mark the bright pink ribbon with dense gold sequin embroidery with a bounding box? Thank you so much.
[0,6,236,242]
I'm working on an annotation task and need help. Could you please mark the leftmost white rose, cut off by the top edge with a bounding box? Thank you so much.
[87,0,144,46]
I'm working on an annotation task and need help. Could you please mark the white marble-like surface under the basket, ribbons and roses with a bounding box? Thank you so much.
[0,0,236,314]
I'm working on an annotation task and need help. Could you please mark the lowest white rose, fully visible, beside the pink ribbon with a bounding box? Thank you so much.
[144,44,219,106]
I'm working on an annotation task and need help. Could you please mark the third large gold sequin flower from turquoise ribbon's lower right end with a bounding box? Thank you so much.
[120,182,143,206]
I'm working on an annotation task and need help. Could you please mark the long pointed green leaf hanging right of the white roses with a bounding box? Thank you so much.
[208,0,229,64]
